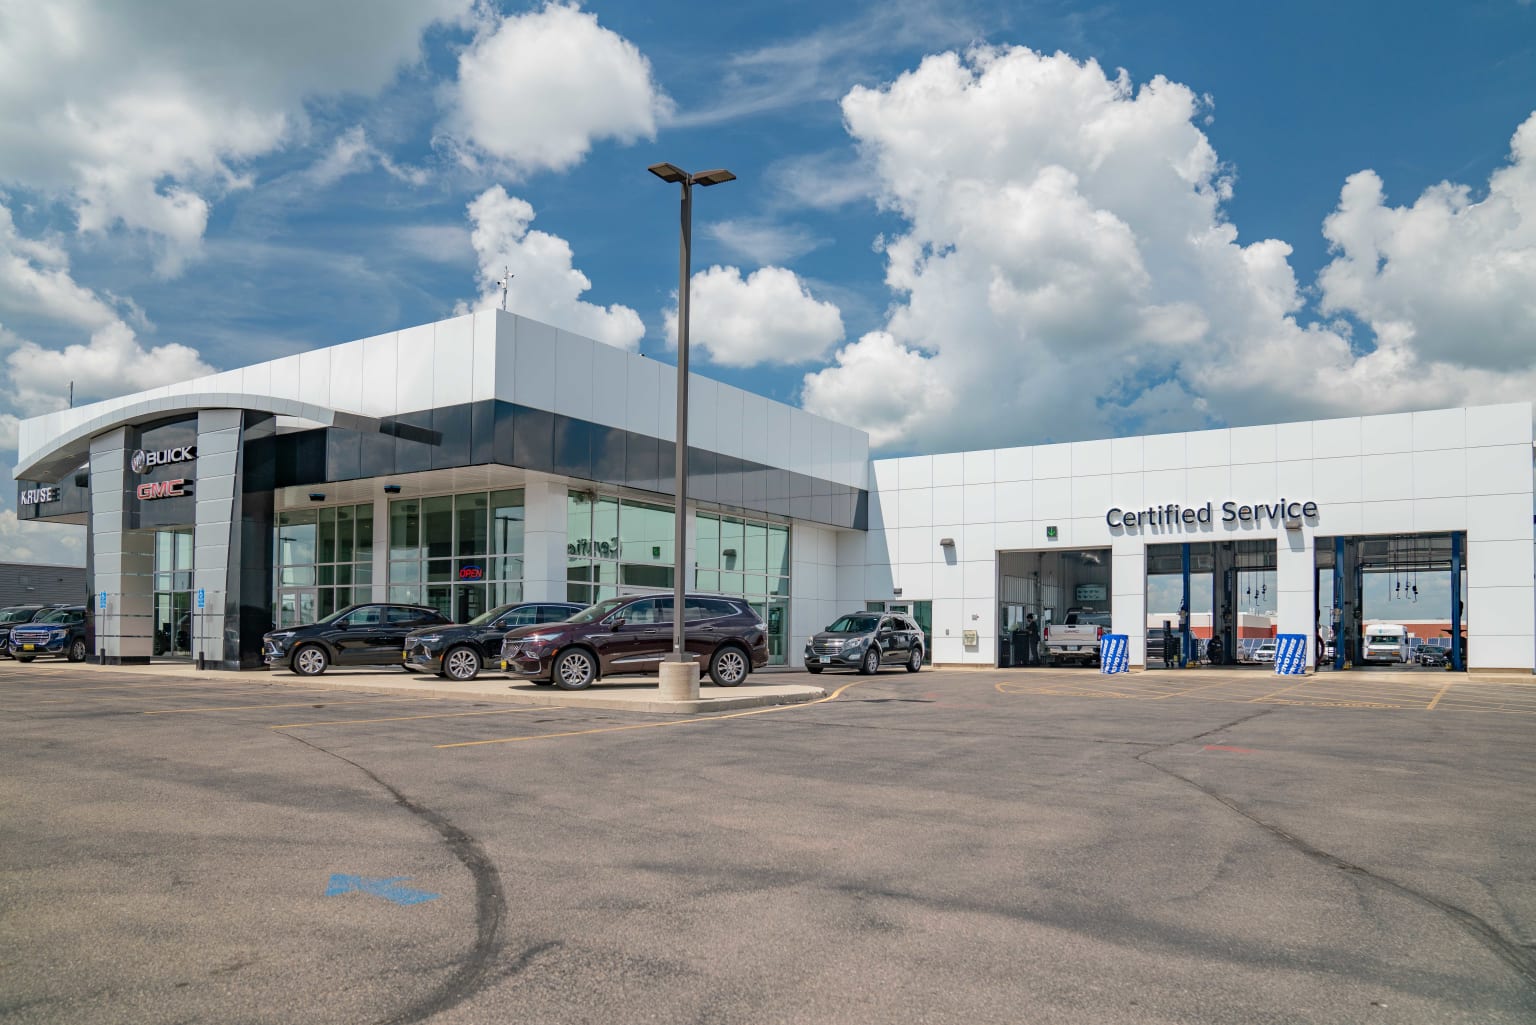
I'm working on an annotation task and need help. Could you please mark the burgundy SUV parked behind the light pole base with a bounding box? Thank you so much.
[501,595,768,690]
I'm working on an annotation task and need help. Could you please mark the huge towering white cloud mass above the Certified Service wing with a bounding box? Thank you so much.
[803,48,1536,449]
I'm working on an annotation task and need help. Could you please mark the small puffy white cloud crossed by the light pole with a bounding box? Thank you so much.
[665,267,843,367]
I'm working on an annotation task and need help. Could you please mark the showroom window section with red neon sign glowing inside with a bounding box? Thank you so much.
[389,489,524,622]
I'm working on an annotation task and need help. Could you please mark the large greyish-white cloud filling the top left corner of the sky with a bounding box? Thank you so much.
[0,0,472,274]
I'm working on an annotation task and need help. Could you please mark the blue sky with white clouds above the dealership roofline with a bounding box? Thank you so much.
[0,0,1536,561]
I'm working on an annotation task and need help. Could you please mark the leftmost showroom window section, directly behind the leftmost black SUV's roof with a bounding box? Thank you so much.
[273,504,373,627]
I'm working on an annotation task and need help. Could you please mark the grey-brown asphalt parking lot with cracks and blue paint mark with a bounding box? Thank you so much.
[0,664,1536,1025]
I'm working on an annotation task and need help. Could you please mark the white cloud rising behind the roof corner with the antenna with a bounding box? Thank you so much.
[459,184,645,350]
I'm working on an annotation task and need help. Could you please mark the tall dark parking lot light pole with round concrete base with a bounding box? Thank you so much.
[650,163,736,701]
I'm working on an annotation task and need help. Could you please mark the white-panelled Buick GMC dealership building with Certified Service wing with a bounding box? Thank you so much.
[15,310,1536,672]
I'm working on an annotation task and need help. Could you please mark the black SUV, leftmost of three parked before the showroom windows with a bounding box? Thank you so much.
[261,604,449,676]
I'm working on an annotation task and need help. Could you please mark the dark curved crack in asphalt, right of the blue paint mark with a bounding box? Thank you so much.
[283,733,507,1025]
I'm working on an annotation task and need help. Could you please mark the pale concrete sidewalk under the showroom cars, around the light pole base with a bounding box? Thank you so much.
[69,661,826,715]
